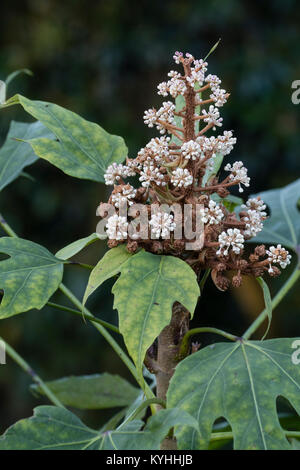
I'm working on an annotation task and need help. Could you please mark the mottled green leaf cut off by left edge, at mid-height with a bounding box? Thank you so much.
[0,237,63,319]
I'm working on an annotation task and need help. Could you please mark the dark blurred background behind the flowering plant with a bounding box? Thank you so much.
[0,0,300,432]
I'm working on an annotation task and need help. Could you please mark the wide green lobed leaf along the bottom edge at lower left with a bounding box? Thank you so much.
[0,406,198,450]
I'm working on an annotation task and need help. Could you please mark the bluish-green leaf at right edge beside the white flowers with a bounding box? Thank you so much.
[246,179,300,253]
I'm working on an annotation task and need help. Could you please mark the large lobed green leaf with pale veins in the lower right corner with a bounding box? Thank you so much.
[167,338,300,450]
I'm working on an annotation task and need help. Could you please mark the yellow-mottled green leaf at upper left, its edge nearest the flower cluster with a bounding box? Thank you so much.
[3,95,127,182]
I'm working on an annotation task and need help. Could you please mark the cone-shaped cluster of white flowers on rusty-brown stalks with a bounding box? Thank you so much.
[99,52,291,290]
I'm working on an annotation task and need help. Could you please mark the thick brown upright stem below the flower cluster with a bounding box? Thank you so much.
[156,303,190,450]
